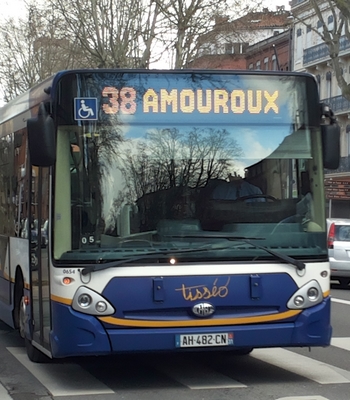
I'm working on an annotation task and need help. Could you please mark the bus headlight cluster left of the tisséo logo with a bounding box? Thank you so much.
[72,286,115,316]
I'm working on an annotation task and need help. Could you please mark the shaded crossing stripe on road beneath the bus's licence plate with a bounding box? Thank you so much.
[154,362,247,389]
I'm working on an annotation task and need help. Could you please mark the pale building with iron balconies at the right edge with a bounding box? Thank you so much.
[290,0,350,218]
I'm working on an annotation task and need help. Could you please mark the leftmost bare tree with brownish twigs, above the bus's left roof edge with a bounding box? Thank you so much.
[0,5,78,101]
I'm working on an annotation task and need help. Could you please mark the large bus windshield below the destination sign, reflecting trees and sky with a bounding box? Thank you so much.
[54,73,326,262]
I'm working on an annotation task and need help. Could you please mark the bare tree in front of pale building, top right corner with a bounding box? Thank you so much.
[310,0,350,101]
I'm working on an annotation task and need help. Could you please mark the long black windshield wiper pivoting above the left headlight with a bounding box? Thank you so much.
[81,244,231,275]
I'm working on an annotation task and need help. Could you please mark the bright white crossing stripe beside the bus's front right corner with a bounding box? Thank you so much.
[250,348,350,385]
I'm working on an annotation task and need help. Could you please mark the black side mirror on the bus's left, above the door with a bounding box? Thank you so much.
[27,103,56,167]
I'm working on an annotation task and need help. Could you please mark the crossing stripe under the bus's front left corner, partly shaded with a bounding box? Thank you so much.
[6,347,115,400]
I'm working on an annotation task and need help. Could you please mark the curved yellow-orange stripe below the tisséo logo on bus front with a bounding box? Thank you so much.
[98,310,302,328]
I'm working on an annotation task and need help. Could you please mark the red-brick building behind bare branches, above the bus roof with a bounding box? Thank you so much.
[191,6,291,70]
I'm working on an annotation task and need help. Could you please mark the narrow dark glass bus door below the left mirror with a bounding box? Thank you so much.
[30,167,51,351]
